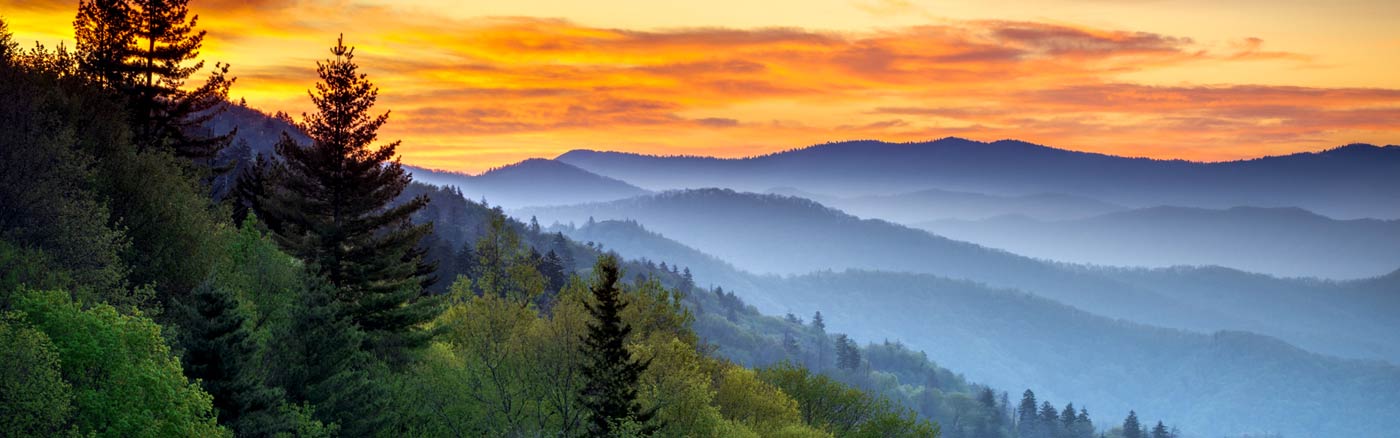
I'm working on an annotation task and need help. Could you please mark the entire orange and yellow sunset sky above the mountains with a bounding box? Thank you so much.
[0,0,1400,172]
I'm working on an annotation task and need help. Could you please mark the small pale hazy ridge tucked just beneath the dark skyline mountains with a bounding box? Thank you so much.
[769,188,1126,224]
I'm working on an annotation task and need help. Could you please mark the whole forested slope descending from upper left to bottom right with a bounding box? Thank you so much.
[0,0,1176,438]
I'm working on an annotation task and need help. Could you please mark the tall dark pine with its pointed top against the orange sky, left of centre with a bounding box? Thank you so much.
[253,38,438,364]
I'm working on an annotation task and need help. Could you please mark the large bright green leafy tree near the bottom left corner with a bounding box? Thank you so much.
[15,291,227,437]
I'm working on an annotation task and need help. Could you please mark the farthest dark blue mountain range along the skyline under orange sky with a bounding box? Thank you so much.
[556,137,1400,218]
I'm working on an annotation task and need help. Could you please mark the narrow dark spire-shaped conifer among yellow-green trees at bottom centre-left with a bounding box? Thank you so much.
[581,255,654,435]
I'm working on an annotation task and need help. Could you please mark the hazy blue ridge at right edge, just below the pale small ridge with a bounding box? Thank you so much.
[916,207,1400,278]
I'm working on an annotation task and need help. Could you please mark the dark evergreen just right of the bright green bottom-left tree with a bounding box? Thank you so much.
[182,281,291,437]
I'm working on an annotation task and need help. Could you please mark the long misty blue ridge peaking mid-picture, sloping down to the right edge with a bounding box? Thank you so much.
[514,189,1400,362]
